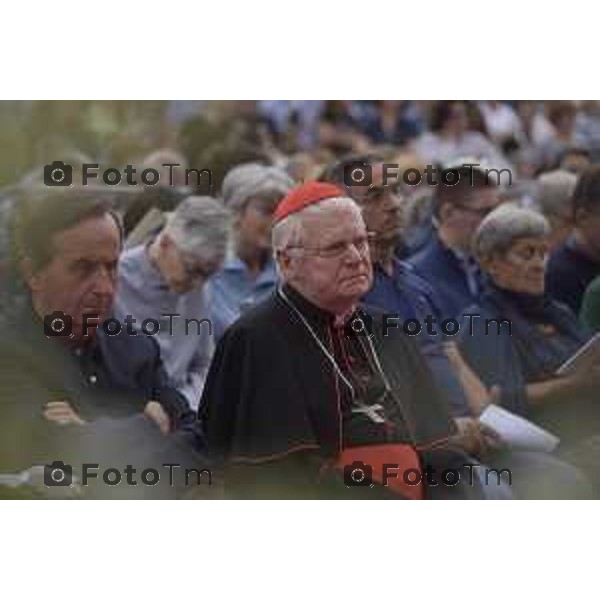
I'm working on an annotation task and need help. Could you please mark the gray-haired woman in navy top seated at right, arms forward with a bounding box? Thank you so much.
[459,205,600,478]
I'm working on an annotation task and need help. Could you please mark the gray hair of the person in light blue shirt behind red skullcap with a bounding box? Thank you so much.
[221,163,295,212]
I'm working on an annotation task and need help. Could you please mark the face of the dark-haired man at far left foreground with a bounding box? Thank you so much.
[27,214,121,341]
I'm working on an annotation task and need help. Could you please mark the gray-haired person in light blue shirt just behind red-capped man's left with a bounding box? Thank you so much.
[209,163,294,340]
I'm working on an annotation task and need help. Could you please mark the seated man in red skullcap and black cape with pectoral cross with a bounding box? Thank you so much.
[200,182,488,498]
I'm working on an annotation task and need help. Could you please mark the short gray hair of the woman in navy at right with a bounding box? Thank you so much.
[473,204,550,261]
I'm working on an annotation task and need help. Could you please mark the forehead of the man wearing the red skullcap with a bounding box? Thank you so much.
[302,201,366,246]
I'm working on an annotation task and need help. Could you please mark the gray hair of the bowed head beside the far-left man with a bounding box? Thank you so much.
[162,196,229,258]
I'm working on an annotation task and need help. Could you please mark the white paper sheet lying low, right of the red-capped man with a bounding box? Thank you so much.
[479,404,560,452]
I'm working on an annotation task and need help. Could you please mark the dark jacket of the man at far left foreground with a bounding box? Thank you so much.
[0,305,194,472]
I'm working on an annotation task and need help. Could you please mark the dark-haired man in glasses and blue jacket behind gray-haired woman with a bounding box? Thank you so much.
[408,160,501,321]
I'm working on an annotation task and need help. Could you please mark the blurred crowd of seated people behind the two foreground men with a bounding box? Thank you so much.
[0,100,600,496]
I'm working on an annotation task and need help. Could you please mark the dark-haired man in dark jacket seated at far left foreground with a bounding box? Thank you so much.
[0,188,200,492]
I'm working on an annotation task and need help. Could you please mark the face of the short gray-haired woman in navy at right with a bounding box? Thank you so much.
[482,236,550,295]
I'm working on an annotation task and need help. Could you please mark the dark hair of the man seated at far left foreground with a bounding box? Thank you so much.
[9,188,123,271]
